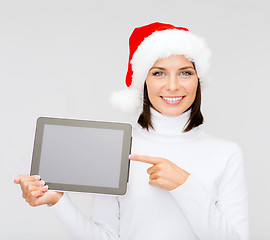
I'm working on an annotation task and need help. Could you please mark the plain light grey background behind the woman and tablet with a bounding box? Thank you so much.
[0,0,270,240]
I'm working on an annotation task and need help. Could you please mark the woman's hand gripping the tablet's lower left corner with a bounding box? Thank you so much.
[14,175,63,207]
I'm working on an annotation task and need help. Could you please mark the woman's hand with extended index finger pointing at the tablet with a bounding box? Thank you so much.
[129,154,190,191]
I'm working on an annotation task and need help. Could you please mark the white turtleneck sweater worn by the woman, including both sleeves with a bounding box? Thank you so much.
[51,109,248,240]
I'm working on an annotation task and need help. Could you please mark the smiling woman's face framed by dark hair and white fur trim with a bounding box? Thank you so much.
[146,55,198,116]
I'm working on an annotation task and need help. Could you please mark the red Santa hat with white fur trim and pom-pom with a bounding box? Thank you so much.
[110,22,211,113]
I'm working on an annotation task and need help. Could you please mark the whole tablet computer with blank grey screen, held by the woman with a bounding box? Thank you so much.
[30,117,132,195]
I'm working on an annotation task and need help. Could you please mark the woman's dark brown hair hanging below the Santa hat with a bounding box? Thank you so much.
[138,78,203,132]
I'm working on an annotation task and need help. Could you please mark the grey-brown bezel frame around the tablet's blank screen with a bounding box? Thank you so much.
[30,117,132,195]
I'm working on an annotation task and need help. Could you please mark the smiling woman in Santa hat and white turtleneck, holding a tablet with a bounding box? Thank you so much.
[15,23,248,240]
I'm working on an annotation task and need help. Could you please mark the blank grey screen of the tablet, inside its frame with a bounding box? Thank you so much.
[39,124,123,188]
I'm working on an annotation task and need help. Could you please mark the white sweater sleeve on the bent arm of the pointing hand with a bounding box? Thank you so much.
[170,146,248,240]
